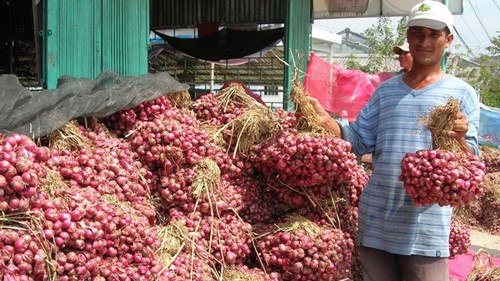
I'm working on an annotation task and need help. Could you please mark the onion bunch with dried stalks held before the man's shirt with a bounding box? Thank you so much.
[399,98,485,207]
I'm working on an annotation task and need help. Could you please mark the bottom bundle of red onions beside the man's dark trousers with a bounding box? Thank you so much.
[257,217,354,281]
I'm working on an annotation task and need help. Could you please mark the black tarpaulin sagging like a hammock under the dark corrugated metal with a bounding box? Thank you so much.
[153,27,285,62]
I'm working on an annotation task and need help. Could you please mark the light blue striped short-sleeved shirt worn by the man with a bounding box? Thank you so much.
[342,75,479,257]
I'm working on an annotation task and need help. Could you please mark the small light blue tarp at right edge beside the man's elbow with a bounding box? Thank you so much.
[479,104,500,148]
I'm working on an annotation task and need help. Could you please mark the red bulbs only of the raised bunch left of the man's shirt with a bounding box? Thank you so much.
[249,132,357,187]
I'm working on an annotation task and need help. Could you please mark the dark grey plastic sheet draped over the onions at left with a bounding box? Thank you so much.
[0,71,189,138]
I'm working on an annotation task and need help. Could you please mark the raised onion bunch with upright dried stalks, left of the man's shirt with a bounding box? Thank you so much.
[248,71,357,187]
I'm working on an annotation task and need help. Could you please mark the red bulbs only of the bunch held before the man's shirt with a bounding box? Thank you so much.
[399,149,485,206]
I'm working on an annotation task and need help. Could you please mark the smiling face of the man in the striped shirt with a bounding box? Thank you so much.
[407,26,453,65]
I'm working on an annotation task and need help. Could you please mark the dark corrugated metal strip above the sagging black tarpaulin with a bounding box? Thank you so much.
[150,0,285,29]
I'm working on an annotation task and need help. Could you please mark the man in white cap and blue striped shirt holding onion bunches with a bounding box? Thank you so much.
[310,1,479,281]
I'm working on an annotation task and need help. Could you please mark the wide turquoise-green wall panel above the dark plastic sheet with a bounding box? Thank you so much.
[40,0,149,89]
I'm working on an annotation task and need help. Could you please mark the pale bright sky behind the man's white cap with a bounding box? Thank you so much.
[314,0,500,57]
